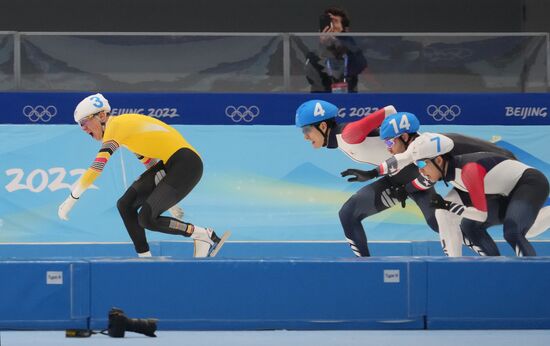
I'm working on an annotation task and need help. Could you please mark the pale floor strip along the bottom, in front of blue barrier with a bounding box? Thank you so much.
[0,330,550,346]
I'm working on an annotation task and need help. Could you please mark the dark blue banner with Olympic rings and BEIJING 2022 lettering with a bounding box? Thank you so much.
[0,92,550,125]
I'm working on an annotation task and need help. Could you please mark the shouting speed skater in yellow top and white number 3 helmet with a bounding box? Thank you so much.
[58,94,229,257]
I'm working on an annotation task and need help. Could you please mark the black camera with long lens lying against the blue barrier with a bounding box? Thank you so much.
[107,308,157,338]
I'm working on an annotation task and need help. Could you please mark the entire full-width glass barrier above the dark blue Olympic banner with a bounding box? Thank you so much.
[0,33,549,92]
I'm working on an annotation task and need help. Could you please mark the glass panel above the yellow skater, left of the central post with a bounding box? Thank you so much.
[17,34,283,92]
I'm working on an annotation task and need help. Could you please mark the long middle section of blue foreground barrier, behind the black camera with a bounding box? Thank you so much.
[91,257,425,330]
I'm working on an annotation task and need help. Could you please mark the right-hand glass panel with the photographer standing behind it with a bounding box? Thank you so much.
[290,34,548,92]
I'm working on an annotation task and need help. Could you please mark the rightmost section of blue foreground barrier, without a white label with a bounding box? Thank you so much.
[426,257,550,329]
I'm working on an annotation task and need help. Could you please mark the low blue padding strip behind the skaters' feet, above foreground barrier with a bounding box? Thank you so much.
[0,240,550,259]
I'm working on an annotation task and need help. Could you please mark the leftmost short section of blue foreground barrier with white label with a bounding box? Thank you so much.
[0,261,90,329]
